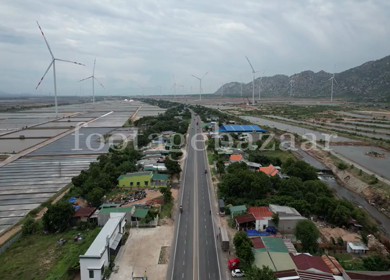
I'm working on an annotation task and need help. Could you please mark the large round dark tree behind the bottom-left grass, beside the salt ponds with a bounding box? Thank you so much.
[42,200,74,232]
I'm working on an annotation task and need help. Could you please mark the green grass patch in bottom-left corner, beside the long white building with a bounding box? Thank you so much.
[0,228,100,280]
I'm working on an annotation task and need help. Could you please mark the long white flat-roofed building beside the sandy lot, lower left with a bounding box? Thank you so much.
[80,213,126,280]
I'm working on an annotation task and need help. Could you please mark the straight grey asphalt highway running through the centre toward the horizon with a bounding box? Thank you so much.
[167,112,223,280]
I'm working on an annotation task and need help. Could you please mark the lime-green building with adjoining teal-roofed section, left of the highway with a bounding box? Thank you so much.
[118,171,169,188]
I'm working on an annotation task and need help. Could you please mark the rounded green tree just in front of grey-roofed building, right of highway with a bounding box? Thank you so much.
[295,220,320,253]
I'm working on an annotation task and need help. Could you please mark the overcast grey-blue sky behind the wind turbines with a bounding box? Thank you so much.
[0,0,390,96]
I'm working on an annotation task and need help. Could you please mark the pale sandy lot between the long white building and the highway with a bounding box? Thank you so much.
[110,226,174,280]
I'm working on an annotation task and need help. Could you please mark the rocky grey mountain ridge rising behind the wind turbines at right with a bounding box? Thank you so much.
[214,56,390,102]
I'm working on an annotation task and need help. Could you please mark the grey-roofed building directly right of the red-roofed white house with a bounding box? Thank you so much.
[269,204,306,233]
